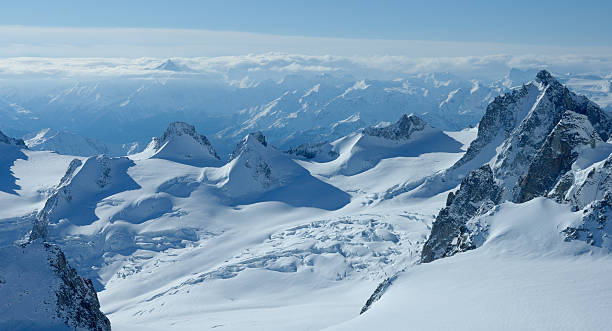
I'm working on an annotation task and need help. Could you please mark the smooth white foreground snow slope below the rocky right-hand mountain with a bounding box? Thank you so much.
[330,198,612,330]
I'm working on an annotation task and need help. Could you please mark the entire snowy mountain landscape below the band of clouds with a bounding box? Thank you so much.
[0,59,612,330]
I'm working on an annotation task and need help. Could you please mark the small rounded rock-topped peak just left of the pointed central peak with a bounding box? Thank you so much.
[143,122,221,167]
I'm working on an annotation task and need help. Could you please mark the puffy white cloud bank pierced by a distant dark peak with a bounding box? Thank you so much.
[0,52,612,82]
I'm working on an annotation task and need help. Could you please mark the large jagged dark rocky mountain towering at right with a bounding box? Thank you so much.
[421,70,612,262]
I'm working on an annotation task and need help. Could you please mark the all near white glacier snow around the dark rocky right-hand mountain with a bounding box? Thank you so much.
[0,113,612,330]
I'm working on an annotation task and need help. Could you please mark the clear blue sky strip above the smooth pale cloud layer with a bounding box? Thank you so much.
[0,0,612,46]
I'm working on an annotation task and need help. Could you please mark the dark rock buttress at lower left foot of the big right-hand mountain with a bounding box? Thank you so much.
[421,165,502,262]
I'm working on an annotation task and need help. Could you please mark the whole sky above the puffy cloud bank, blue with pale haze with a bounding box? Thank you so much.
[0,0,612,57]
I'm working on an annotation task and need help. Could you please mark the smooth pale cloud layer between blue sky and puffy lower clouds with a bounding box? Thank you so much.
[0,26,612,58]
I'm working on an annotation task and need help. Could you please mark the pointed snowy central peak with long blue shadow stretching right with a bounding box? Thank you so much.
[203,132,350,209]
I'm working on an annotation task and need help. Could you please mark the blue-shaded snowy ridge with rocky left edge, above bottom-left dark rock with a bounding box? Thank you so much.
[30,155,139,240]
